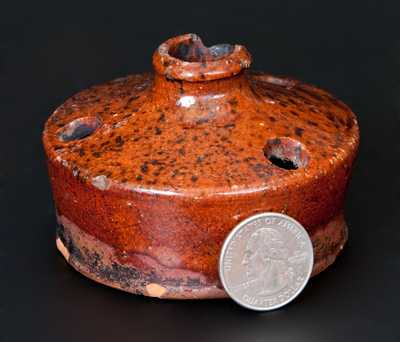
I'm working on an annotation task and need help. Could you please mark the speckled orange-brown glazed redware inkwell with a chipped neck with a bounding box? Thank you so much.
[43,34,359,299]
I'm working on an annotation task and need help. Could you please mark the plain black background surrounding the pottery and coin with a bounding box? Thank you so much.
[0,0,400,342]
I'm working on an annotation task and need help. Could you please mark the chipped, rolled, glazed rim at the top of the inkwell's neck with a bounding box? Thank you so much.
[153,33,251,82]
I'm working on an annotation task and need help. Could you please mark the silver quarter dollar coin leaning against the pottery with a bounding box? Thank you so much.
[219,213,314,311]
